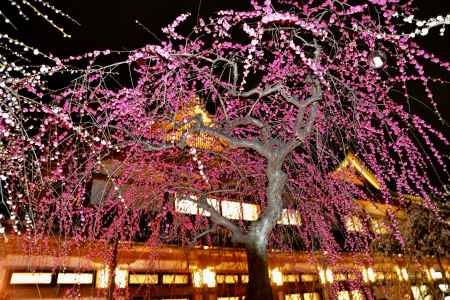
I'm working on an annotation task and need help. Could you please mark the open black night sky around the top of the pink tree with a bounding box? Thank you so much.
[0,0,450,138]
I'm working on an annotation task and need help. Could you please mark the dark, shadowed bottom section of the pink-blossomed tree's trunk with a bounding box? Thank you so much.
[245,242,273,300]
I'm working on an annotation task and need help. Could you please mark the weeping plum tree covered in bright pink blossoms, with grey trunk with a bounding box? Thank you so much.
[0,0,449,299]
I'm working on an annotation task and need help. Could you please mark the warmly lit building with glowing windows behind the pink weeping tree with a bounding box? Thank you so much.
[0,103,450,300]
